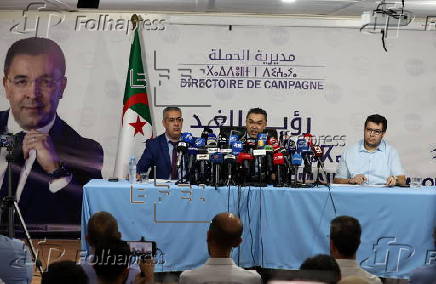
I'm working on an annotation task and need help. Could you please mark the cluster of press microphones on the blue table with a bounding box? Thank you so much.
[177,128,324,187]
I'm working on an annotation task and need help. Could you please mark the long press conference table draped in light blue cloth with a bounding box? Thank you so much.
[81,180,436,278]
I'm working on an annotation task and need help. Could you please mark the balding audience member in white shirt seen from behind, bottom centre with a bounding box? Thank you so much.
[179,213,262,284]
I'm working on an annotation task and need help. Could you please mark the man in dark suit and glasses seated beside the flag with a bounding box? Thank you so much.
[136,107,183,179]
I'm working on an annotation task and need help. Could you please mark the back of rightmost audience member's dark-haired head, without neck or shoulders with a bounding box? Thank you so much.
[330,216,362,258]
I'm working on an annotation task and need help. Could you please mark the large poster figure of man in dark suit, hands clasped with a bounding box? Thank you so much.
[0,38,103,224]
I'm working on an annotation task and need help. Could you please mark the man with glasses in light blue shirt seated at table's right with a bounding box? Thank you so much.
[334,114,406,186]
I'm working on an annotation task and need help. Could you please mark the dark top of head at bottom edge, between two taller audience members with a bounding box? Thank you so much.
[300,254,341,283]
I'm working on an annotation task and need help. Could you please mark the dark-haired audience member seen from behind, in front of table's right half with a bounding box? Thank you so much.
[330,216,381,284]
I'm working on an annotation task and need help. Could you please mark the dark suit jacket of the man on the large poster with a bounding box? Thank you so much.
[0,111,103,224]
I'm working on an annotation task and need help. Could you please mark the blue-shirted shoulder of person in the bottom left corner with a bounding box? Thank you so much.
[0,235,33,284]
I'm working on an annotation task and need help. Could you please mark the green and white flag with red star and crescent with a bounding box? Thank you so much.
[114,26,153,178]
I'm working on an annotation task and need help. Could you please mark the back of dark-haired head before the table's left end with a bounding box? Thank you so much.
[87,211,121,247]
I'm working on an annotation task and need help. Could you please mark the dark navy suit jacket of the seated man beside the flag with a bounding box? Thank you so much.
[136,133,171,179]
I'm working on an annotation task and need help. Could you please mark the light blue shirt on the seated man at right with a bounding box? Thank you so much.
[336,140,404,185]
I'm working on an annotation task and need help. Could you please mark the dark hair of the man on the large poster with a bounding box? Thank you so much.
[3,37,66,75]
